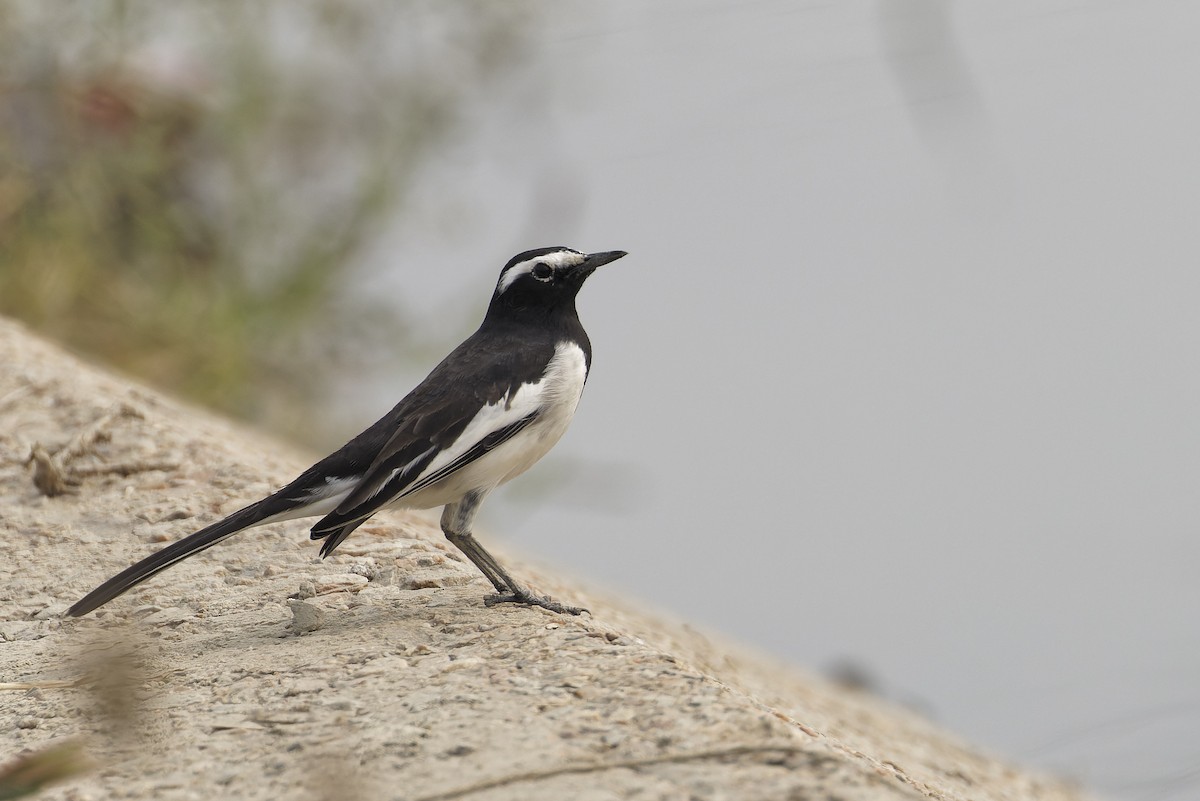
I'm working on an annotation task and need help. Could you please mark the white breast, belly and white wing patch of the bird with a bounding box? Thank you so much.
[394,342,588,508]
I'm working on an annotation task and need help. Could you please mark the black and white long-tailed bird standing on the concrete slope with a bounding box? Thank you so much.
[67,247,625,616]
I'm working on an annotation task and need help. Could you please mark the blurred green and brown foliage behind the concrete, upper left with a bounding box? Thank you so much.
[0,0,529,436]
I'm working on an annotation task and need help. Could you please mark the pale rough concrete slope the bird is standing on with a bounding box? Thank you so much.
[0,320,1082,801]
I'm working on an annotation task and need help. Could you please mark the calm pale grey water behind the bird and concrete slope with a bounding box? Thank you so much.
[338,0,1200,800]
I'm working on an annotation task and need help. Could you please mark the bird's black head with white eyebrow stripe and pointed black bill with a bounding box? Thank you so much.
[487,247,625,317]
